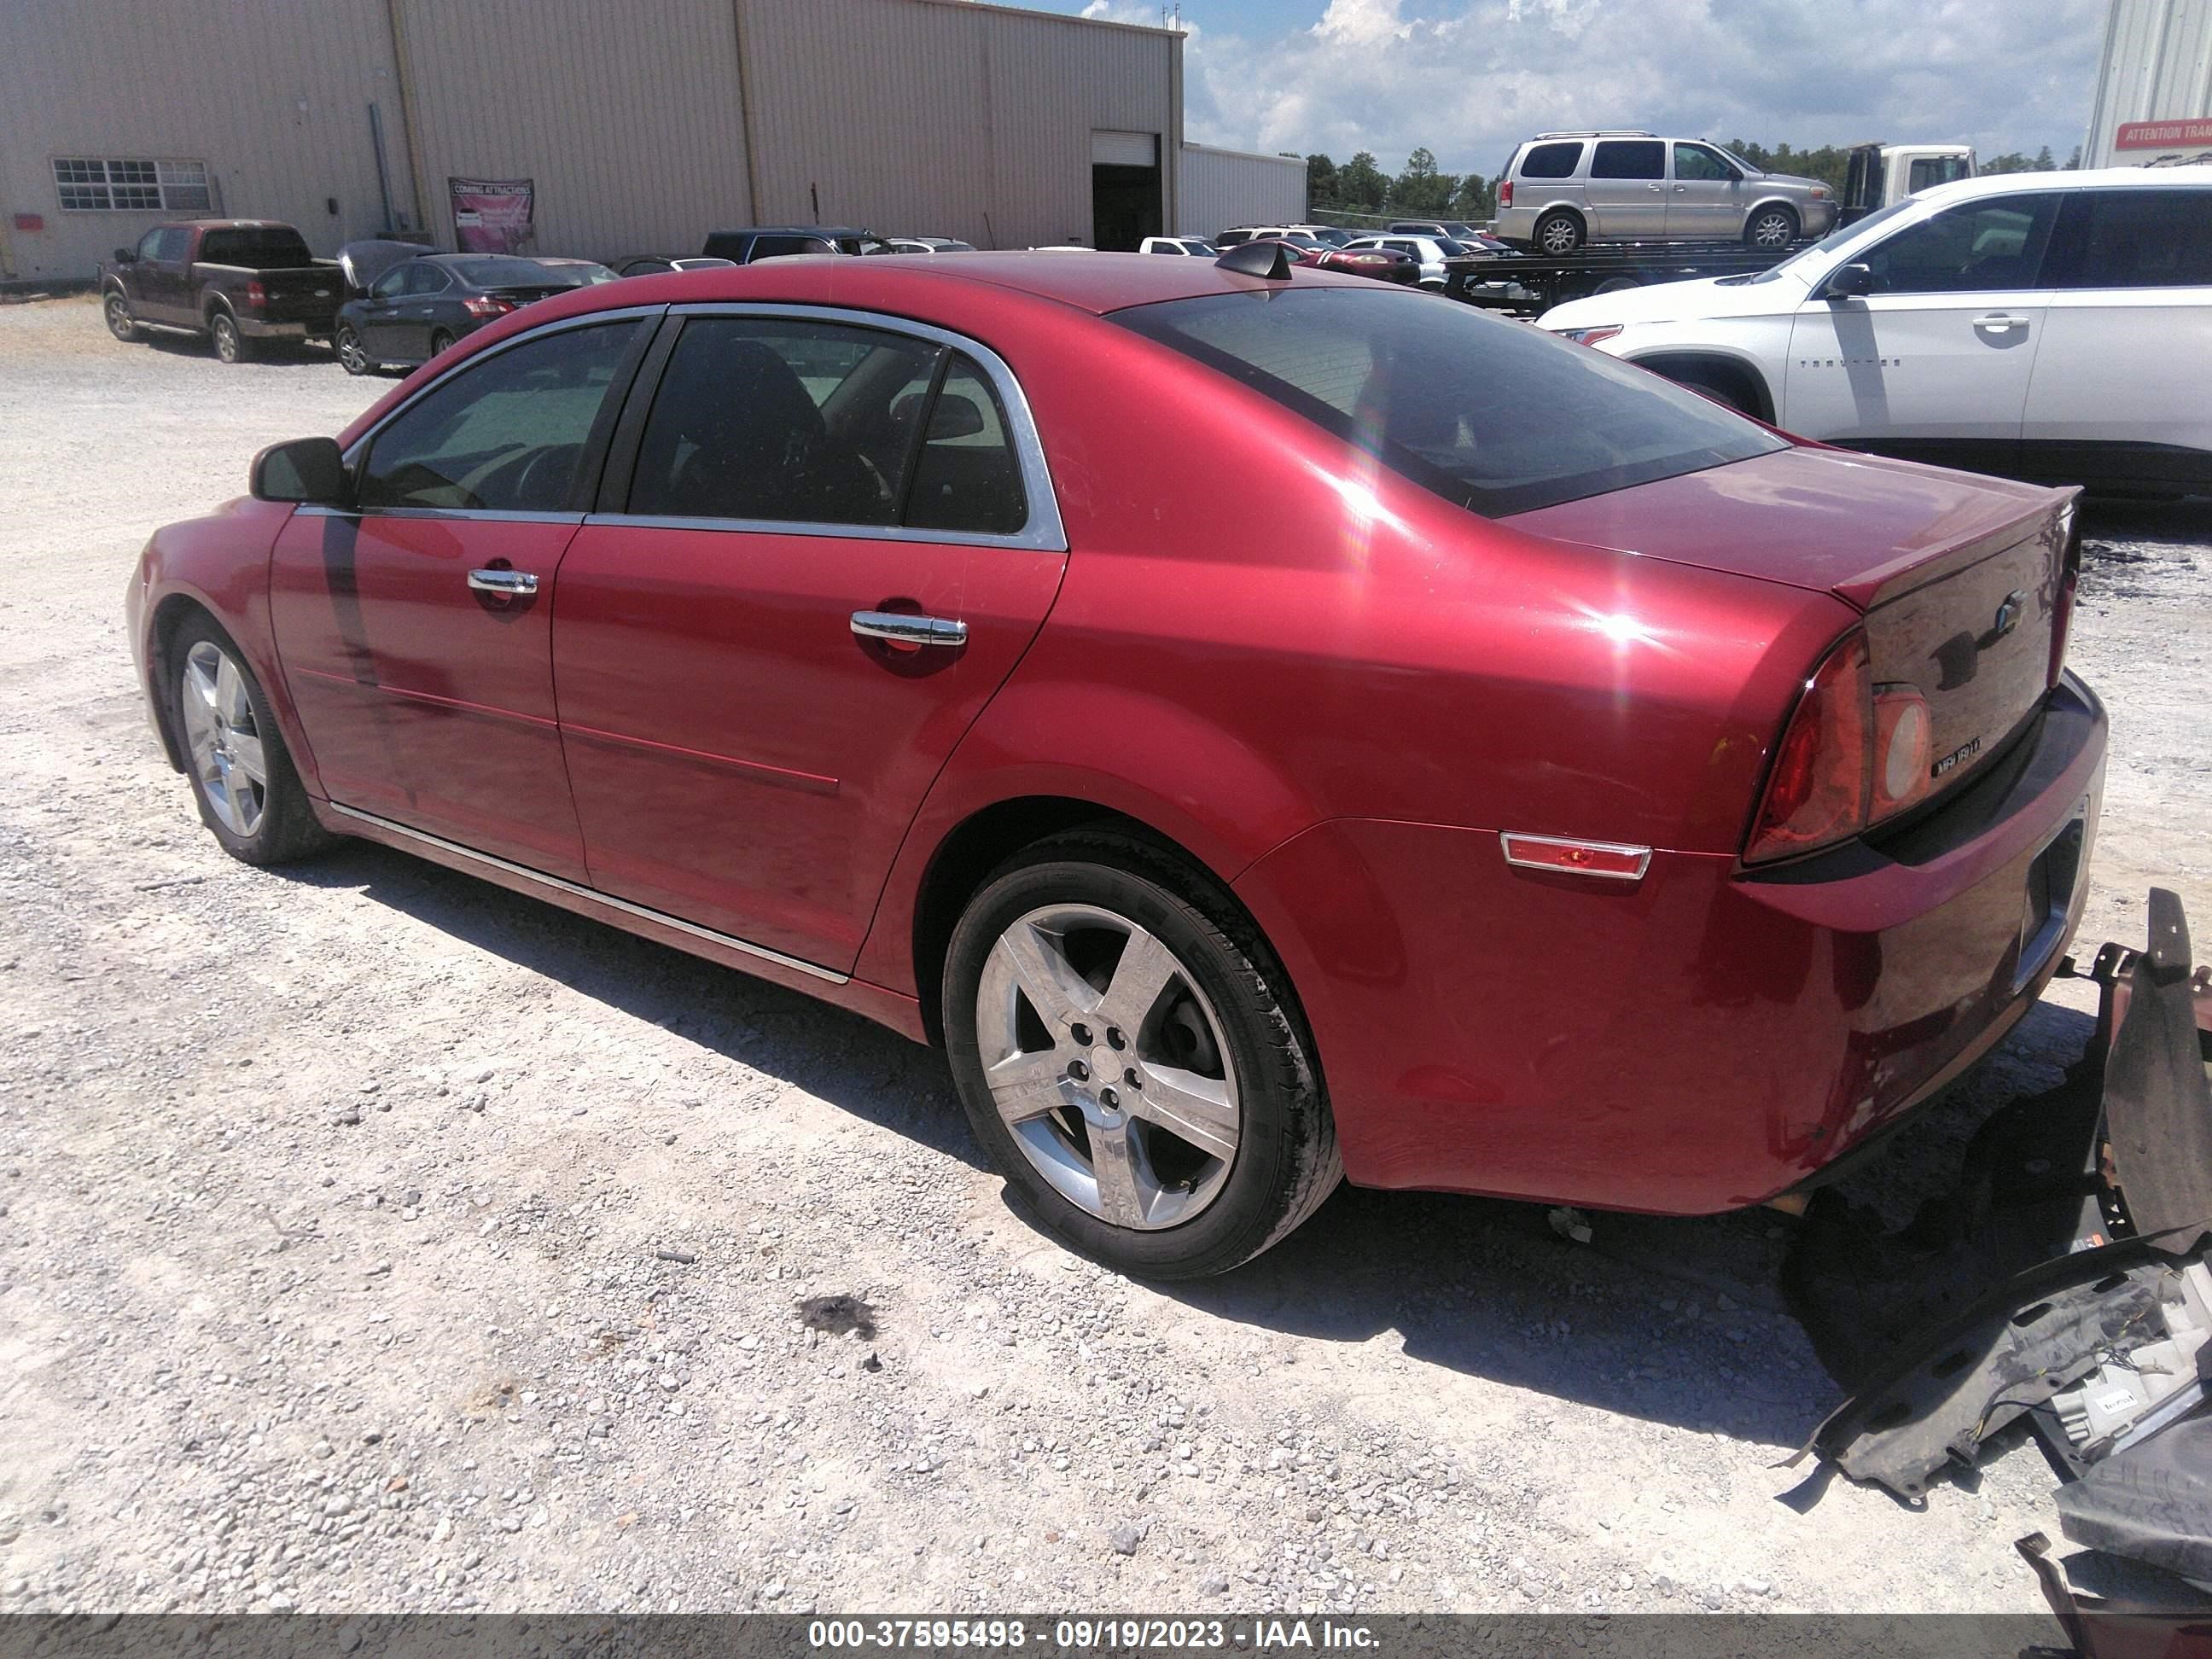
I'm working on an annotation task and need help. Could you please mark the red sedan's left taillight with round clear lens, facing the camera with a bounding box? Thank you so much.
[1743,628,1936,864]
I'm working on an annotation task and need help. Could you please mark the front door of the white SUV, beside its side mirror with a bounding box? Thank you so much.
[1781,190,2059,471]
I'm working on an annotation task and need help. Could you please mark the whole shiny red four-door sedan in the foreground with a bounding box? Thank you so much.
[131,254,2106,1277]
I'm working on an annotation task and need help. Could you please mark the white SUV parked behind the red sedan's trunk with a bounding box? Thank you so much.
[1540,166,2212,493]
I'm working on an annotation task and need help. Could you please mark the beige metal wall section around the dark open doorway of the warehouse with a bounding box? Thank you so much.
[739,0,1184,247]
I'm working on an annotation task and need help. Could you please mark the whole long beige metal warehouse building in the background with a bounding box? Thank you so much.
[0,0,1305,281]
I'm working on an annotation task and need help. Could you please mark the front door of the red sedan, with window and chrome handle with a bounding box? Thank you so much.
[270,311,646,881]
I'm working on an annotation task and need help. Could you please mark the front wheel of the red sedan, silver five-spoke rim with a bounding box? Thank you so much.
[168,615,332,864]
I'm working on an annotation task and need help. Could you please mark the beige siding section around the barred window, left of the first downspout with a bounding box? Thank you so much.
[0,0,411,281]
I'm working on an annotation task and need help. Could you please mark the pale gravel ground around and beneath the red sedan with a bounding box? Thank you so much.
[0,301,2212,1610]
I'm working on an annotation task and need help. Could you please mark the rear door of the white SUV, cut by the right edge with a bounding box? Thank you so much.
[2019,186,2212,489]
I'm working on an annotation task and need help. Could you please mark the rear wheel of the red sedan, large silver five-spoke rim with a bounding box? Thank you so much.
[942,832,1342,1278]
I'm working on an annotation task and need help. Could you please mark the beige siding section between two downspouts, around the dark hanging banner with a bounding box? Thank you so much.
[393,0,752,259]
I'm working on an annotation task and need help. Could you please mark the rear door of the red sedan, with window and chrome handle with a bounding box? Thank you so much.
[553,307,1066,971]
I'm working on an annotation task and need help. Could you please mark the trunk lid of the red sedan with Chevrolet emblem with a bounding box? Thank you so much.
[1506,447,2077,795]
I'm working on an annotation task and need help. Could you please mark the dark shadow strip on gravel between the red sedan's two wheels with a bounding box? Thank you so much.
[279,841,982,1168]
